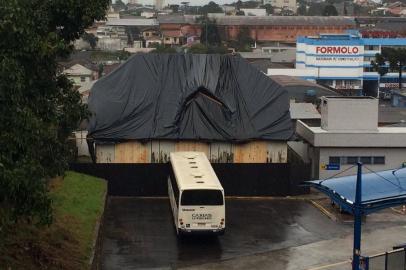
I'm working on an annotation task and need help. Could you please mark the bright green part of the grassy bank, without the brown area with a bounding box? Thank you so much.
[51,171,107,261]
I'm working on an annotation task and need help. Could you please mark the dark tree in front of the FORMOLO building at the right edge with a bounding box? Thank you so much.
[371,47,406,89]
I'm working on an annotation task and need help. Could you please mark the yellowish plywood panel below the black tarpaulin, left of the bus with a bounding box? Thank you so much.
[115,141,151,163]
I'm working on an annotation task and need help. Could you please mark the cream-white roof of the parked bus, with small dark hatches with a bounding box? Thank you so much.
[170,152,223,190]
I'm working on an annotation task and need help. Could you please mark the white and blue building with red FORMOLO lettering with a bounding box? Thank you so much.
[268,31,406,96]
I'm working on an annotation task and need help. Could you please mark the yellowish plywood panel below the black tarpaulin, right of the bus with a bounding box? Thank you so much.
[233,141,268,163]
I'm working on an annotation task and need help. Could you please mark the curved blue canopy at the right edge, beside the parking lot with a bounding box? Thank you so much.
[305,168,406,214]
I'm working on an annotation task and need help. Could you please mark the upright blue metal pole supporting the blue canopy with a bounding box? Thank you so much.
[352,162,362,270]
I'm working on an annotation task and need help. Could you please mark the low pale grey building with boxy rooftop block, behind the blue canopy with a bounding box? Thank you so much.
[296,97,406,179]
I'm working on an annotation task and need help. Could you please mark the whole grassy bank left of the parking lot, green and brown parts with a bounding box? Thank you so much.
[0,172,107,270]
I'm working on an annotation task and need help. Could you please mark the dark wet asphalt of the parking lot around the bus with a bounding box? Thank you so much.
[101,197,358,270]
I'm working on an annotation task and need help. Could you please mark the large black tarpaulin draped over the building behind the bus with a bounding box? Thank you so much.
[88,54,294,141]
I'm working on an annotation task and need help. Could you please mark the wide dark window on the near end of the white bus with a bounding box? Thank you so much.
[180,189,223,205]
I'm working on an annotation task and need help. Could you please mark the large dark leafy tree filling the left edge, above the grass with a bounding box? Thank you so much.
[0,0,109,228]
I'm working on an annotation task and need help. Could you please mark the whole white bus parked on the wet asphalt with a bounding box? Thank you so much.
[168,152,226,235]
